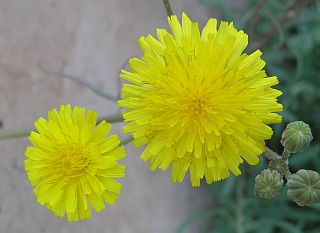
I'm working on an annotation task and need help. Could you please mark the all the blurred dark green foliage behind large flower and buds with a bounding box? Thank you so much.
[177,0,320,233]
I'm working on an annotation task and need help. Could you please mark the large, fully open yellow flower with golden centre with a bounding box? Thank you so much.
[118,14,283,186]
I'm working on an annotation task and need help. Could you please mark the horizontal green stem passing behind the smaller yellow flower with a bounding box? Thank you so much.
[0,114,123,140]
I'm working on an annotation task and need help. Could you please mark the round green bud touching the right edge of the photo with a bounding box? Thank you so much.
[287,169,320,206]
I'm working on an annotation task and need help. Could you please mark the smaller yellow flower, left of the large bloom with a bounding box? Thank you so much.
[24,105,126,221]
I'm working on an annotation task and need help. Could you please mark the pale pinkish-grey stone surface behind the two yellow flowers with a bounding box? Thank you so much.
[0,0,214,233]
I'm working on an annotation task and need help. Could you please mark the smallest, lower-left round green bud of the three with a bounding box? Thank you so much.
[254,169,283,199]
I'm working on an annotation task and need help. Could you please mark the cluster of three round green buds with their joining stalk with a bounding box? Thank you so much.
[254,121,320,206]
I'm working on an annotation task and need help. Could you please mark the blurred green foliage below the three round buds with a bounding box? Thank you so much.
[177,166,320,233]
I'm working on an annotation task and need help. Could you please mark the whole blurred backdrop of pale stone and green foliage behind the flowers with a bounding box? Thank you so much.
[0,0,320,233]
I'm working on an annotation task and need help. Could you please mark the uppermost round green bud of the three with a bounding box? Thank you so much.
[281,121,313,153]
